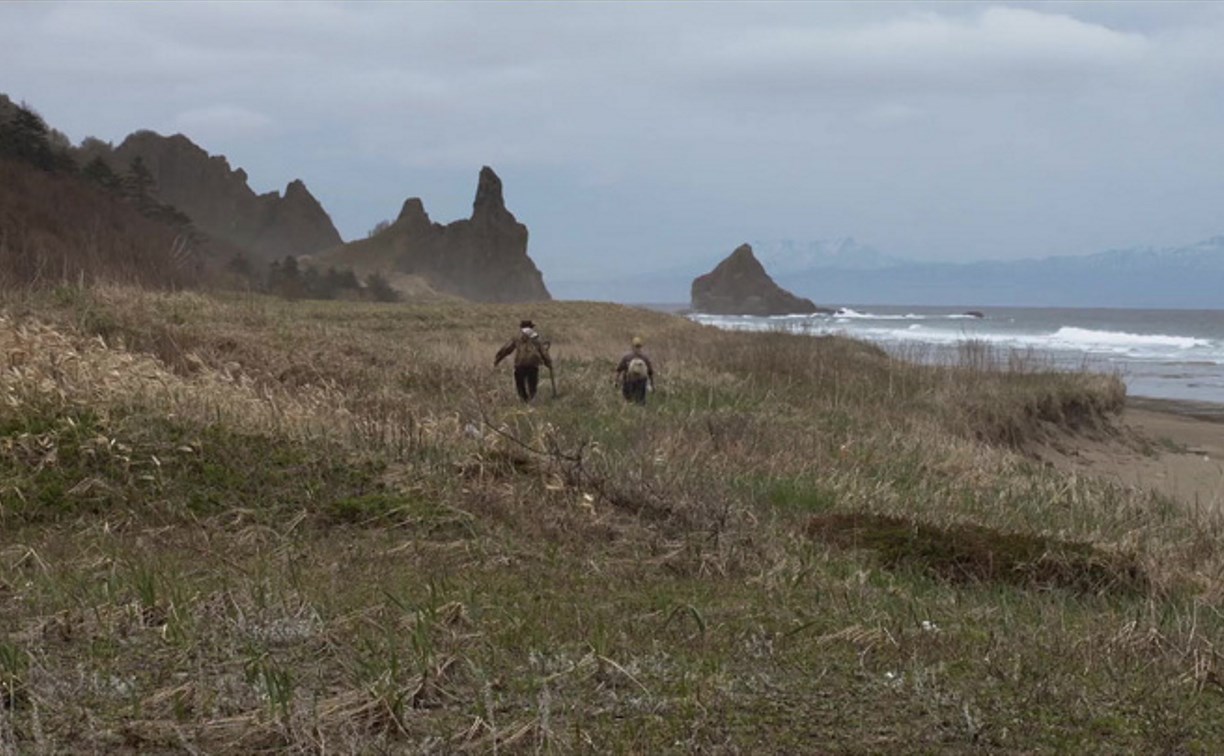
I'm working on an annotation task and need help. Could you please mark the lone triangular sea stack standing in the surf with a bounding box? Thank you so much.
[692,245,827,316]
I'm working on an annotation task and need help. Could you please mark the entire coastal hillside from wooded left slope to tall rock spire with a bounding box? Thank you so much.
[0,94,550,302]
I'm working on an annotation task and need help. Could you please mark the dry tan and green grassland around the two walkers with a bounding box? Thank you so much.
[0,282,1224,754]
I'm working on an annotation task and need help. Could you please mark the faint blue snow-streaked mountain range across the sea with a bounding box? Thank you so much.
[553,236,1224,309]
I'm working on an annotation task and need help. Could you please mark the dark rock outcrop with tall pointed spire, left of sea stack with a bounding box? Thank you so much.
[312,165,551,302]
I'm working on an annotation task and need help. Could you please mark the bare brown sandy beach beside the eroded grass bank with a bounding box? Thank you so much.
[1038,396,1224,509]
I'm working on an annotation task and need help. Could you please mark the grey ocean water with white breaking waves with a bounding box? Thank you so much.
[688,305,1224,404]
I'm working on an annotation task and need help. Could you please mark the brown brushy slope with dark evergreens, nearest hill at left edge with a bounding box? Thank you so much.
[0,95,399,302]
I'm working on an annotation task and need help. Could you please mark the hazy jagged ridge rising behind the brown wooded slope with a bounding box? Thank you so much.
[92,131,341,262]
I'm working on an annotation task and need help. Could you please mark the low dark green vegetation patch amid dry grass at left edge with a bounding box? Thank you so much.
[0,407,386,525]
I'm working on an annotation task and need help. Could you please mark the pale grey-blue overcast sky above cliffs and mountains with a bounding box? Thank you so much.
[0,1,1224,289]
